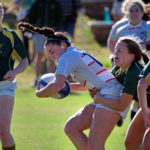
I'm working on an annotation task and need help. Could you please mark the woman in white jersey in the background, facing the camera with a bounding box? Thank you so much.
[108,0,150,53]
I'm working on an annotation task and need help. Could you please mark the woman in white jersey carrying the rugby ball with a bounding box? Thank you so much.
[19,23,144,150]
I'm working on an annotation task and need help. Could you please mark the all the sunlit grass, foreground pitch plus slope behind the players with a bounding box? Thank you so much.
[1,0,130,150]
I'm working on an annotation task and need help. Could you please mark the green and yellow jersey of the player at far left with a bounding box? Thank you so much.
[0,28,27,81]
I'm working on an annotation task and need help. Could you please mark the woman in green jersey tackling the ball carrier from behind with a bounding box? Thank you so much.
[92,37,149,150]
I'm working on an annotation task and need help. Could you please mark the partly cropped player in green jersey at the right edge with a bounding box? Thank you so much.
[126,61,150,150]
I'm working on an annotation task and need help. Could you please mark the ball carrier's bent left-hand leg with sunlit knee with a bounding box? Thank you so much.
[64,104,95,150]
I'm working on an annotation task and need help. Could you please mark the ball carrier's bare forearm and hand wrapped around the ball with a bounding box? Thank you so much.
[36,74,66,97]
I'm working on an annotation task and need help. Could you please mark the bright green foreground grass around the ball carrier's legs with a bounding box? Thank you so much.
[8,88,129,150]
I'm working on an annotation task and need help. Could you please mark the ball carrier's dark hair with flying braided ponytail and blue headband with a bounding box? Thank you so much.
[18,22,72,46]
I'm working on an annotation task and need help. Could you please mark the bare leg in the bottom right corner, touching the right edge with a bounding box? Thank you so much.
[143,128,150,150]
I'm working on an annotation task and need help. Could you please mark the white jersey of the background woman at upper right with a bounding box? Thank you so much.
[116,20,150,44]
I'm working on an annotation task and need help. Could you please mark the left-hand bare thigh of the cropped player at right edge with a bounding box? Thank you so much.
[125,109,145,150]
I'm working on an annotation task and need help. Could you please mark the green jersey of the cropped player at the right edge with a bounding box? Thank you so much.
[139,61,150,108]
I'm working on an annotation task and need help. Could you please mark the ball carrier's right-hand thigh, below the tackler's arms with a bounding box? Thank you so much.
[89,108,120,150]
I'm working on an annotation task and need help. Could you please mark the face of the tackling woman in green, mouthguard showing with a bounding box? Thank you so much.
[114,41,133,69]
